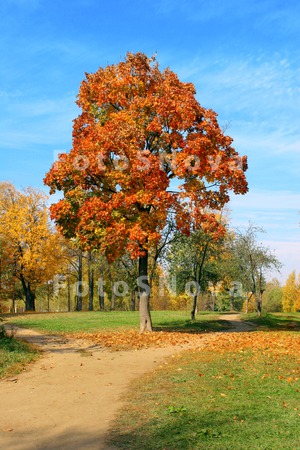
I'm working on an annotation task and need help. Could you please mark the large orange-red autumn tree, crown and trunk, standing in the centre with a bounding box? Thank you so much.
[45,53,247,331]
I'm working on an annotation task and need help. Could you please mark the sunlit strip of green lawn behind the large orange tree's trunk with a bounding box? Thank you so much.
[5,311,229,333]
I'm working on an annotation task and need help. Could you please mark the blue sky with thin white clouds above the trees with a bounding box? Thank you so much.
[0,0,300,281]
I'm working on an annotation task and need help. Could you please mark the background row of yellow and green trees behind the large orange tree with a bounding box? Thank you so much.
[0,182,284,319]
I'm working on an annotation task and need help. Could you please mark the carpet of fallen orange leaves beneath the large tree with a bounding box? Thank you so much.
[72,330,300,366]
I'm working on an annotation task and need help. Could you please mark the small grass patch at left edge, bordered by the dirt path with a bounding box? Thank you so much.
[0,329,39,378]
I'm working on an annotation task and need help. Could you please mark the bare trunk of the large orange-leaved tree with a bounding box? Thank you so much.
[138,250,152,333]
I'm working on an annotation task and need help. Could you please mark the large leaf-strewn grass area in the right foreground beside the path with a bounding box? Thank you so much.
[111,332,300,450]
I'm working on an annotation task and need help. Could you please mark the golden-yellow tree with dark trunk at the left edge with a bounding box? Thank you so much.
[0,183,65,311]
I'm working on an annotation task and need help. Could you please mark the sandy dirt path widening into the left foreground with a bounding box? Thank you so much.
[0,315,253,450]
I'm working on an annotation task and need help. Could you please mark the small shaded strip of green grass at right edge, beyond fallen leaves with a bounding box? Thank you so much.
[242,313,300,331]
